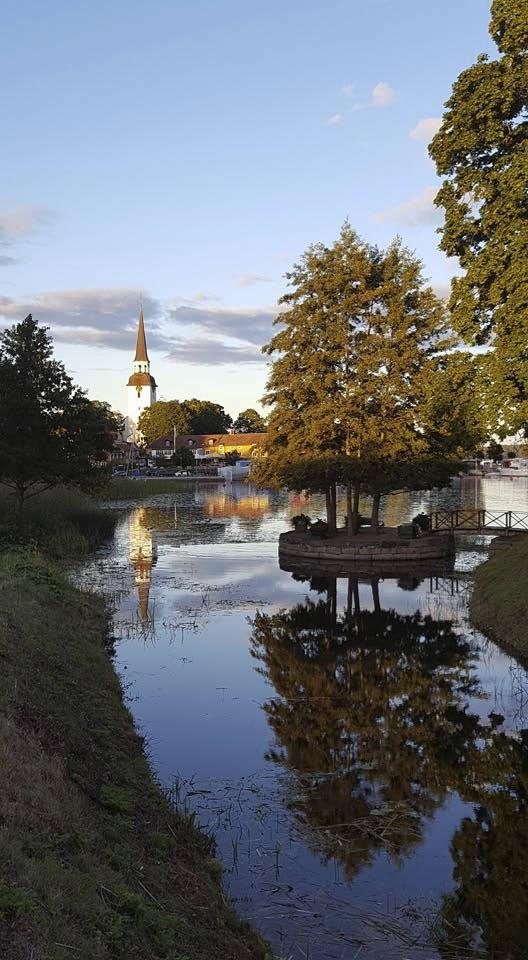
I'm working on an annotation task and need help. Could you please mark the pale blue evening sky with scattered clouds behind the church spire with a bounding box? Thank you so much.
[0,0,494,416]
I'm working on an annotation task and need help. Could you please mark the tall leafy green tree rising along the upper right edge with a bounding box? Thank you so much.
[430,0,528,435]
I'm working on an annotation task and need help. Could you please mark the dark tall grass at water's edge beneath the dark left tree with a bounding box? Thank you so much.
[0,484,115,559]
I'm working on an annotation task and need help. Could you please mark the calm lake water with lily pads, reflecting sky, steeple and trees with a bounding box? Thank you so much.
[76,479,528,960]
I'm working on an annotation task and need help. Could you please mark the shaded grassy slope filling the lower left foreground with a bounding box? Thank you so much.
[0,548,266,960]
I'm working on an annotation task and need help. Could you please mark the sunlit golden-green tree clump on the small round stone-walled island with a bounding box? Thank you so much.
[257,223,466,529]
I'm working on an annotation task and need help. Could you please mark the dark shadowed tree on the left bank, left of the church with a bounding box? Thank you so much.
[0,314,121,511]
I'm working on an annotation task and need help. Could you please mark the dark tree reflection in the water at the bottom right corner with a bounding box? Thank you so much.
[438,728,528,960]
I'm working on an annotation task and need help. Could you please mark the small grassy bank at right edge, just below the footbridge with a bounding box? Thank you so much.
[470,534,528,660]
